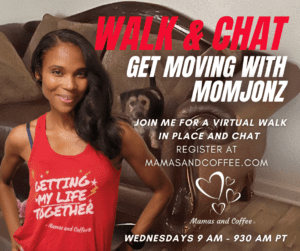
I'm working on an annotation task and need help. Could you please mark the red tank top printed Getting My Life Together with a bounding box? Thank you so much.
[13,114,120,251]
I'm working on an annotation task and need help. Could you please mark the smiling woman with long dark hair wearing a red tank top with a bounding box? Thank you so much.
[0,30,173,251]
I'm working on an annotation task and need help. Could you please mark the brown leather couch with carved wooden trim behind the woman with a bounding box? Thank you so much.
[0,2,300,249]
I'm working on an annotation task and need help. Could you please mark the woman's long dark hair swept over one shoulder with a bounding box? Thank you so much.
[31,29,122,159]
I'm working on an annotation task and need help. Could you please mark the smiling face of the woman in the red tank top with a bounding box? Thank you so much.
[36,42,88,113]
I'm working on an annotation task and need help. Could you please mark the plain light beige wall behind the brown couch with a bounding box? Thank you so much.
[0,0,300,205]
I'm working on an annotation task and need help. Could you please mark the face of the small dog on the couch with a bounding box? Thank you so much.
[125,94,150,120]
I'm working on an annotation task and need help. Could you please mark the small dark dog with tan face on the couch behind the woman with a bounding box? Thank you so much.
[120,68,164,148]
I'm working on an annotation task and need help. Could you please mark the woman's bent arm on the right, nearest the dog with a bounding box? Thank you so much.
[118,123,173,246]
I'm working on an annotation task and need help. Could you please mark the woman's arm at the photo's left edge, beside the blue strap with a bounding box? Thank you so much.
[0,126,29,250]
